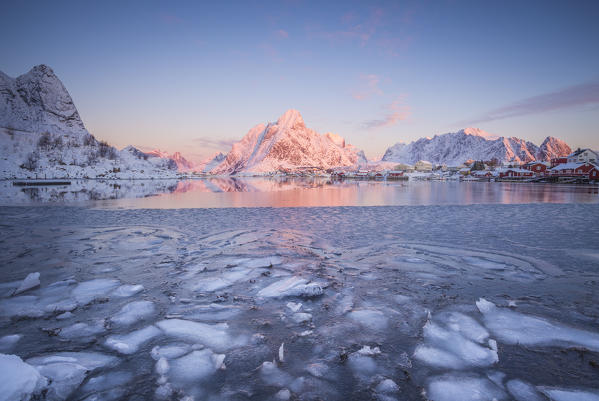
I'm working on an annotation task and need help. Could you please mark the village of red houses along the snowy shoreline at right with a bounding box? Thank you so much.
[330,149,599,184]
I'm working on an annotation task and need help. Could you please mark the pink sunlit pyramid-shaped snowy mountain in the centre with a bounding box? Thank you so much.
[211,110,366,174]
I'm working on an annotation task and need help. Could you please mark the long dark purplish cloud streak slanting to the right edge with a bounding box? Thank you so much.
[456,81,599,125]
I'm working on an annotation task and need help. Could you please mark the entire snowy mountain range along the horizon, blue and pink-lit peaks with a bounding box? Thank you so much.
[0,65,571,178]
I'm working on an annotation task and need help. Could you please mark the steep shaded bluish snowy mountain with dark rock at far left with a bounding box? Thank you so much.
[0,65,177,178]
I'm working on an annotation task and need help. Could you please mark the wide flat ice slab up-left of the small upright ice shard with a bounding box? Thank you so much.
[156,319,248,351]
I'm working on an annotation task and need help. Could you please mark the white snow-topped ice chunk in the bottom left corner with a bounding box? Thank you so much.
[0,354,48,401]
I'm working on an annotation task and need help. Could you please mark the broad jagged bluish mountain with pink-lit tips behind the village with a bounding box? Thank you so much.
[382,128,571,166]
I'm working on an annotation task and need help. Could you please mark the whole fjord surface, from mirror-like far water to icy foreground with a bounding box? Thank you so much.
[0,180,599,401]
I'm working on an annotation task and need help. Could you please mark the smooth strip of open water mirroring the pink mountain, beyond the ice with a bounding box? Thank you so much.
[0,178,599,209]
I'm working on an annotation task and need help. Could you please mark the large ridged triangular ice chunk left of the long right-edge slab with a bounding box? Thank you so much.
[414,320,499,369]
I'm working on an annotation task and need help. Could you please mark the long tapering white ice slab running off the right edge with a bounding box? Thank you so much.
[476,298,599,352]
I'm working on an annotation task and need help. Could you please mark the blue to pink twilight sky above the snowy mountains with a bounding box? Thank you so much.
[0,0,599,160]
